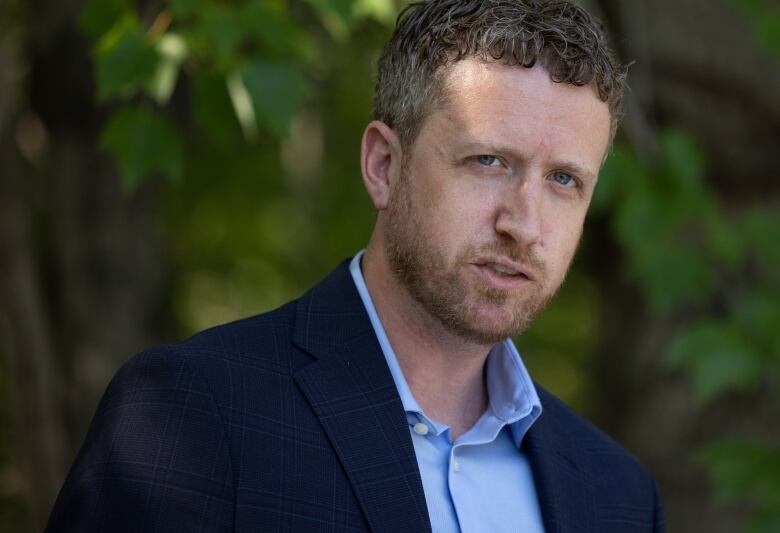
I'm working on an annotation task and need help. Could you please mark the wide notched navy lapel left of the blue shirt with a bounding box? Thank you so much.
[293,262,431,533]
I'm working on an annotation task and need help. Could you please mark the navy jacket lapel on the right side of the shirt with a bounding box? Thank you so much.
[523,385,596,533]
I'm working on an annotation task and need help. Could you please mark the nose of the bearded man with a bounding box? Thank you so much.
[495,179,544,247]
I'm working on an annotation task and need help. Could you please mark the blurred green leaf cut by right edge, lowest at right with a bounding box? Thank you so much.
[698,440,780,505]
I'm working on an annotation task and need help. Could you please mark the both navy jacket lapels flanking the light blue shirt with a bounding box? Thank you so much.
[292,261,597,533]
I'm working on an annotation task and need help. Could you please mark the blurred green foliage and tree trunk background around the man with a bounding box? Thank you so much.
[0,0,780,532]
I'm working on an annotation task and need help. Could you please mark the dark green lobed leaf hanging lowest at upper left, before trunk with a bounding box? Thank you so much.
[100,108,184,190]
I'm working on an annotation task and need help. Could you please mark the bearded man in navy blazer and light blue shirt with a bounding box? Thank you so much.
[49,0,663,533]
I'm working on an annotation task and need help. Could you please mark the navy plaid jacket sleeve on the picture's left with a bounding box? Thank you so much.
[46,347,235,533]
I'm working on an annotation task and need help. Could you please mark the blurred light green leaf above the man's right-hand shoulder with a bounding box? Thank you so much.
[665,321,763,403]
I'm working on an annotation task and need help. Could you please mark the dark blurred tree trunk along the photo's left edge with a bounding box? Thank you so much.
[0,0,170,531]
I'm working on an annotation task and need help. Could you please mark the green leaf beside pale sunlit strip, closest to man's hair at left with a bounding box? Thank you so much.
[242,61,310,135]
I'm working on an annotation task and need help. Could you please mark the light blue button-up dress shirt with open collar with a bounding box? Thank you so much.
[349,251,544,533]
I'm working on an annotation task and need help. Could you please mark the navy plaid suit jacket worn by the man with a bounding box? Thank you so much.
[47,262,663,533]
